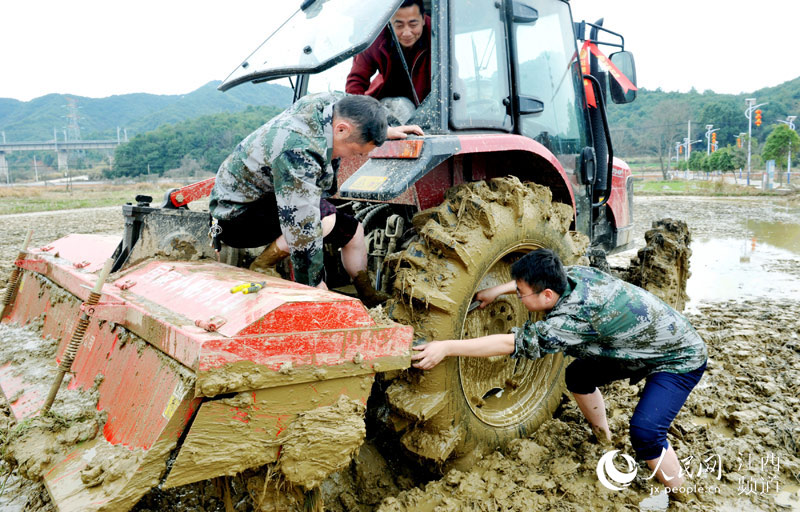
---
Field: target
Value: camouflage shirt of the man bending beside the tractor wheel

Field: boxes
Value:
[511,266,708,382]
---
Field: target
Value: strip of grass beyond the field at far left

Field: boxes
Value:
[0,183,179,215]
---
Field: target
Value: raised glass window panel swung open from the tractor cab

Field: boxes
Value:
[219,0,401,91]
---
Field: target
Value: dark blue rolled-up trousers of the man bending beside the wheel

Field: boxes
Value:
[565,359,706,460]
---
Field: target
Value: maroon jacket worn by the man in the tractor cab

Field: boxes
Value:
[345,16,431,102]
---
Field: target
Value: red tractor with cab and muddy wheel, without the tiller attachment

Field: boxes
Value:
[220,0,636,463]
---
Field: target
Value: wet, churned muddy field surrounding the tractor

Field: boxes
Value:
[0,197,800,512]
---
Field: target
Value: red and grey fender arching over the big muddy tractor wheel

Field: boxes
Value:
[339,133,575,214]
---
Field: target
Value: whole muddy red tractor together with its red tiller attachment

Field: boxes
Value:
[0,0,636,510]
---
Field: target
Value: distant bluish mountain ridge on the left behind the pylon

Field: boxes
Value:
[0,81,292,142]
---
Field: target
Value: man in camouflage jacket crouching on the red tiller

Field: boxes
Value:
[209,93,422,307]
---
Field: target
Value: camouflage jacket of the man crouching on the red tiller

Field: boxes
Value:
[209,93,345,286]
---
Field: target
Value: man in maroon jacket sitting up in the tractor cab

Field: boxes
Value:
[345,0,431,107]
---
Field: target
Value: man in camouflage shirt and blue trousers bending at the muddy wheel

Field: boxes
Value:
[411,249,708,501]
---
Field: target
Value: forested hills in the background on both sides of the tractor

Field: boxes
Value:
[7,73,800,177]
